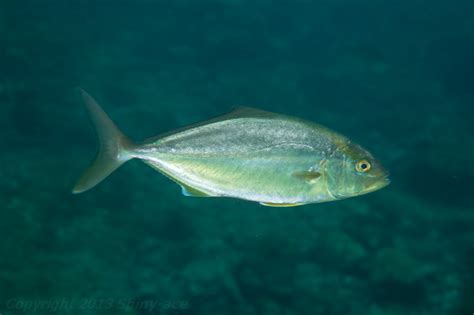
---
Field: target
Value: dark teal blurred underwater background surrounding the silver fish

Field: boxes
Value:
[0,0,474,315]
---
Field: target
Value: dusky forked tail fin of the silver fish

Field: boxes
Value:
[72,89,133,194]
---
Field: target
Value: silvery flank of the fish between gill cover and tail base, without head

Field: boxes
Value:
[138,113,344,204]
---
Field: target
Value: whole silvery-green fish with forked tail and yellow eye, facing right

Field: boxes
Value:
[72,89,390,207]
